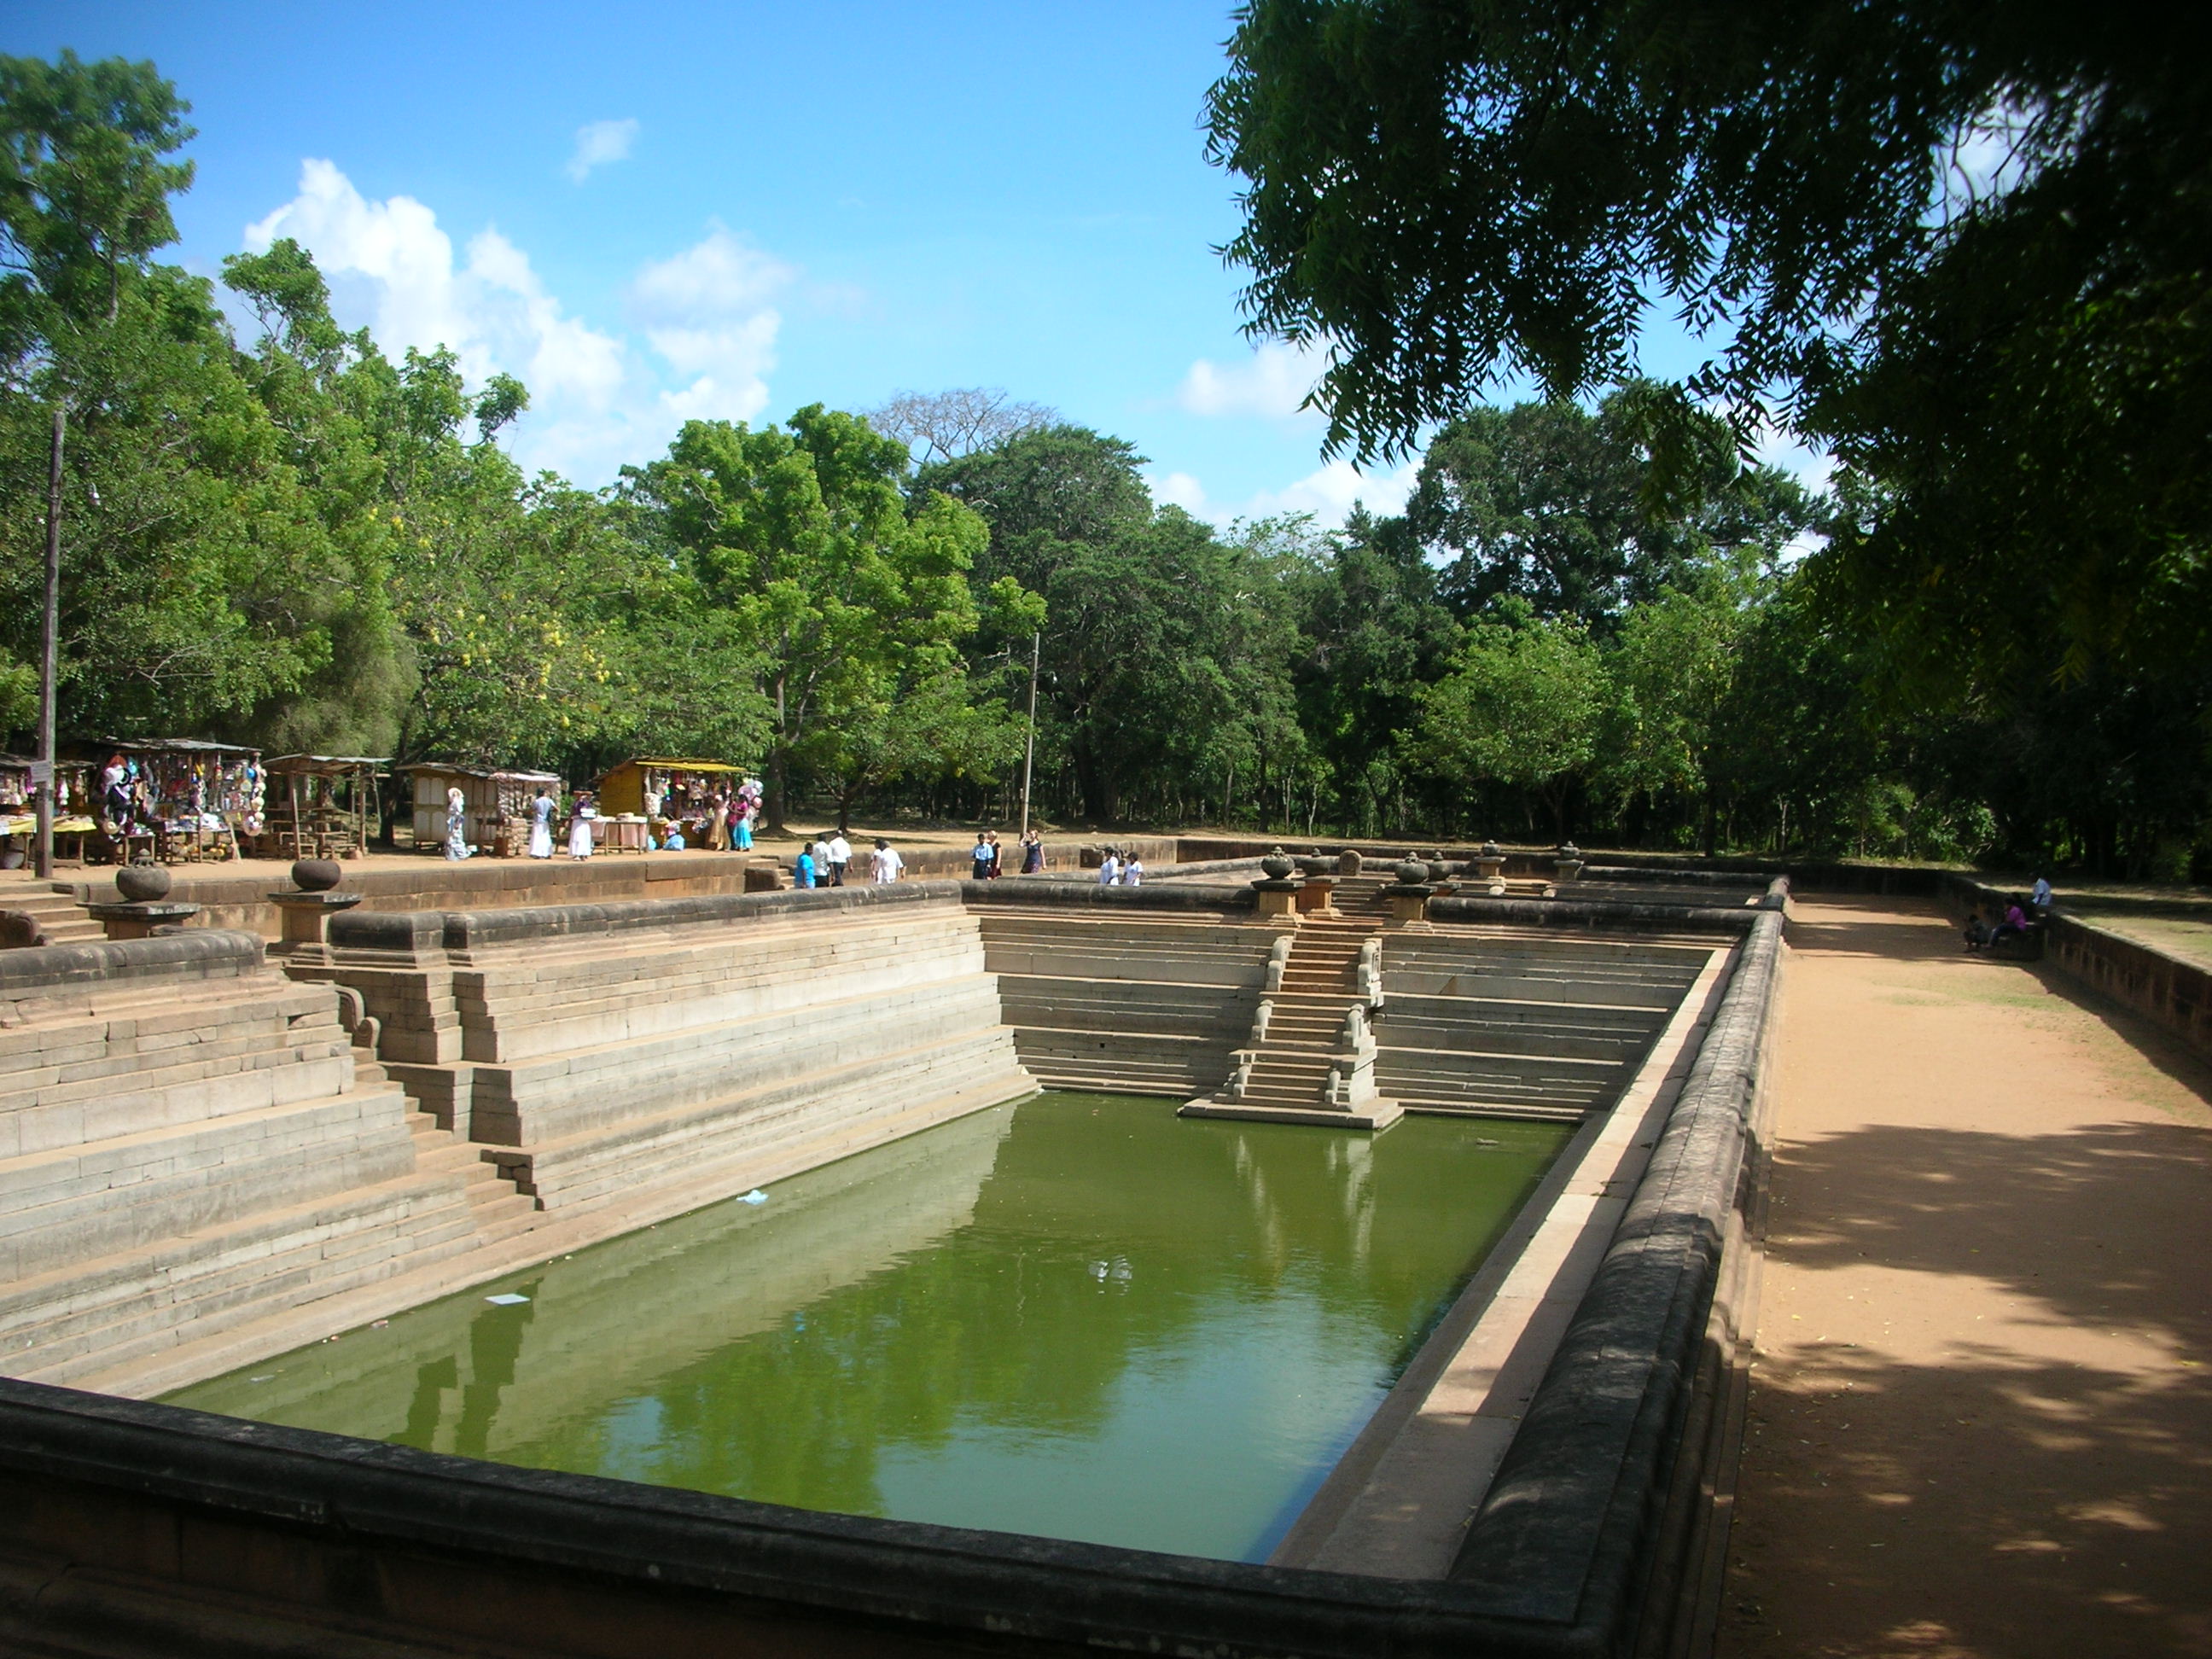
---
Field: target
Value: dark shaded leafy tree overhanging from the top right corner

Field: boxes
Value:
[1210,0,2212,734]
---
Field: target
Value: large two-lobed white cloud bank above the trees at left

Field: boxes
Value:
[243,161,799,485]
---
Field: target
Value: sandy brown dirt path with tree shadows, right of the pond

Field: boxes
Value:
[1719,900,2212,1659]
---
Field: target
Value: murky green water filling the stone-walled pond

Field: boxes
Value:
[168,1092,1569,1559]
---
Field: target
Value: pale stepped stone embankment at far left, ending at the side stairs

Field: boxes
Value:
[0,929,544,1382]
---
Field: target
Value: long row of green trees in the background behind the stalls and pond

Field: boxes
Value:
[0,57,2212,876]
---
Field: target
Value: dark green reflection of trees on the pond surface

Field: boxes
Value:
[568,1099,1559,1513]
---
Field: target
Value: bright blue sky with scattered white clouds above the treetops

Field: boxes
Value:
[0,0,1796,522]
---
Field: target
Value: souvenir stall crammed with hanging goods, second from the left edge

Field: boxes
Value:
[90,736,268,864]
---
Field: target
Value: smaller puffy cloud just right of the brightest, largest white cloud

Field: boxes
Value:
[631,225,799,420]
